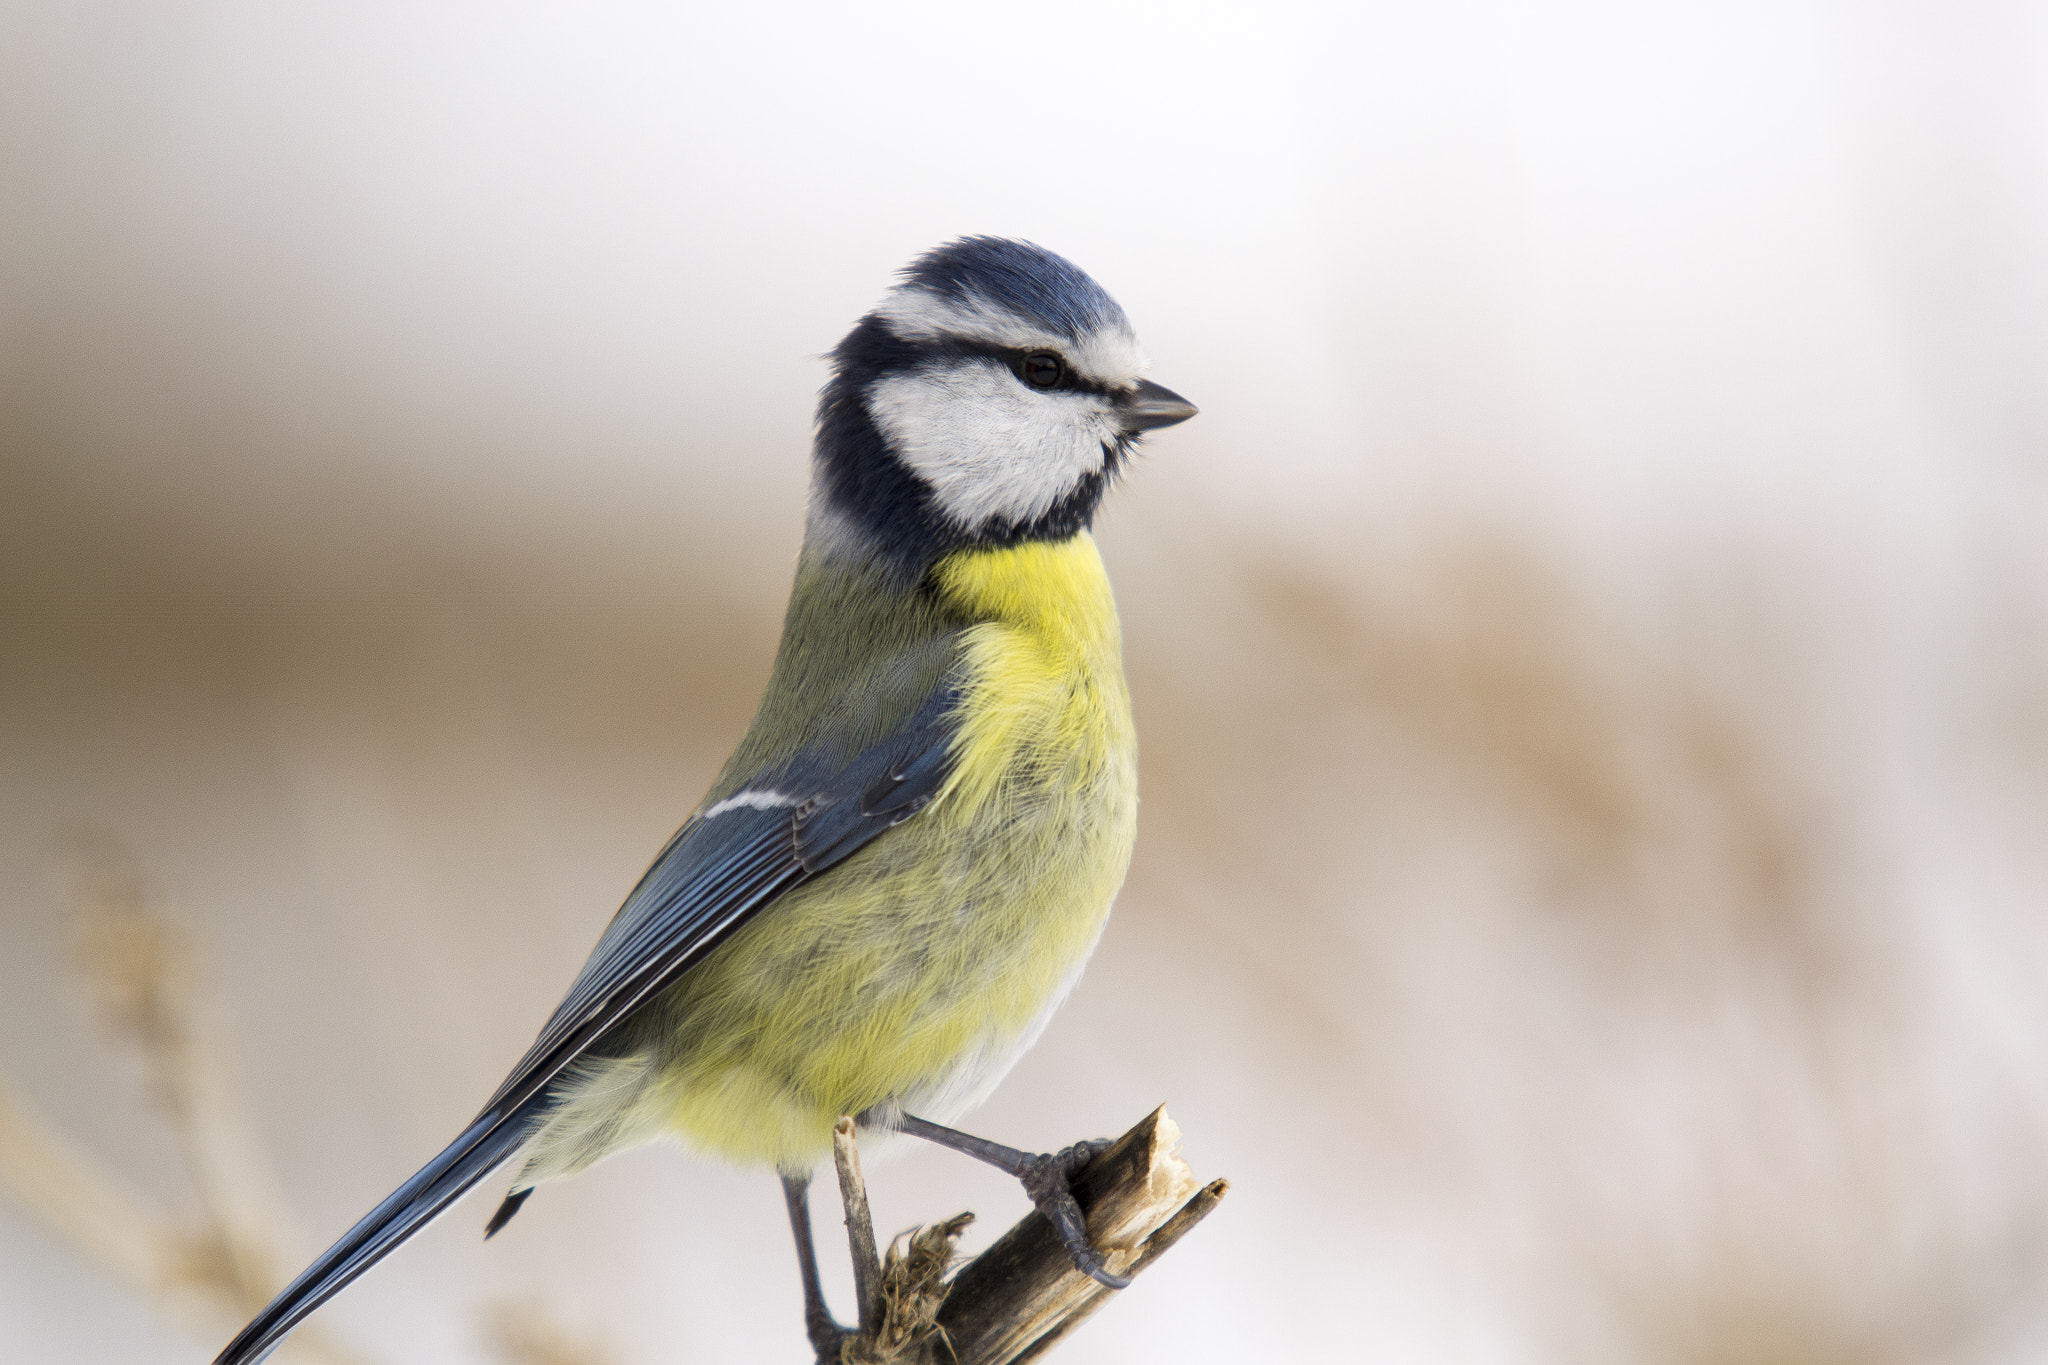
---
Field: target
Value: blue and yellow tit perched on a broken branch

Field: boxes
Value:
[215,235,1196,1365]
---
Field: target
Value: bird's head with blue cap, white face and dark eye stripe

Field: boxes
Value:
[811,237,1194,577]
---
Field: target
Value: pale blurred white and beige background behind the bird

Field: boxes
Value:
[0,0,2048,1365]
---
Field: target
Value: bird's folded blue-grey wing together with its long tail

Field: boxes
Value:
[213,686,954,1365]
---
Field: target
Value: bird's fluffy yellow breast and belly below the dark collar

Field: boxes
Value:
[651,534,1137,1169]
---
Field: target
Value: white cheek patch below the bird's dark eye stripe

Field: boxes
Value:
[868,360,1116,530]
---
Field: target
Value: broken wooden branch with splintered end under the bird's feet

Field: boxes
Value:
[834,1107,1229,1365]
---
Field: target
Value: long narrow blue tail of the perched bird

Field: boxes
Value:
[213,1093,547,1365]
